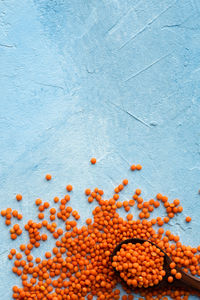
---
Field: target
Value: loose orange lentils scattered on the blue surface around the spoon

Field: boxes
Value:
[1,159,200,300]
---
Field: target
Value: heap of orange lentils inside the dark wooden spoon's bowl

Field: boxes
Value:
[112,242,166,288]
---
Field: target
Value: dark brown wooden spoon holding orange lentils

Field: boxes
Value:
[111,239,200,291]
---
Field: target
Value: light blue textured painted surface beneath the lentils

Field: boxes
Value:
[0,0,200,299]
